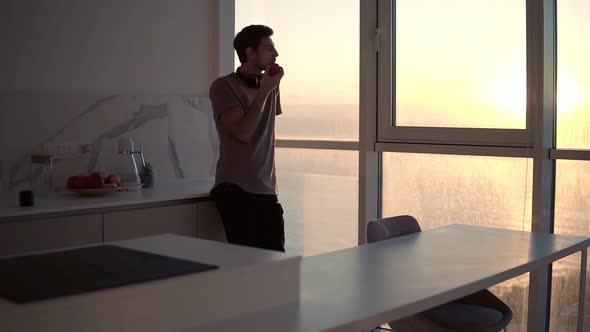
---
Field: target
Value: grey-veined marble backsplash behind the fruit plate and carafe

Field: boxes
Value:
[0,92,218,191]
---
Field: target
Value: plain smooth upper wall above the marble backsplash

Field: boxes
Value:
[0,0,217,94]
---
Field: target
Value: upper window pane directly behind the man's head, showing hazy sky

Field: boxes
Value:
[235,0,360,140]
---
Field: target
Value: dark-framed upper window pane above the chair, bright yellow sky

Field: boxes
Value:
[395,0,526,129]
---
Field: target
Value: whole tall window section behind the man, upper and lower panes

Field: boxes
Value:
[236,0,360,256]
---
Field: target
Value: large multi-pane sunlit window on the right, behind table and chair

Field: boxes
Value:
[376,0,590,331]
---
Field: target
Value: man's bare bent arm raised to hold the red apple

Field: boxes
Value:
[220,68,284,143]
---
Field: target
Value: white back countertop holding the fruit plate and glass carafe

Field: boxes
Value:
[0,178,214,222]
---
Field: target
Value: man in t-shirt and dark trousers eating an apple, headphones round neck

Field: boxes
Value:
[209,25,285,252]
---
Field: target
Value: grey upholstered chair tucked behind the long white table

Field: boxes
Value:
[367,216,513,332]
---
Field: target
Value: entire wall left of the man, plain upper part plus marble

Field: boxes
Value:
[0,0,219,190]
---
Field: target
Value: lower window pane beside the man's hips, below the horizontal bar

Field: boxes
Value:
[276,148,358,256]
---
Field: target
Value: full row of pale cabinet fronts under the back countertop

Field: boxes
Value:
[0,201,226,256]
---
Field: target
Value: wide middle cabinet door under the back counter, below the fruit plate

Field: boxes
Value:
[104,204,197,242]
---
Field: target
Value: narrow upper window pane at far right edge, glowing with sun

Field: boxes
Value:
[557,0,590,149]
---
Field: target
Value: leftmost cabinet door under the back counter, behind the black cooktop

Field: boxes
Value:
[0,214,102,256]
